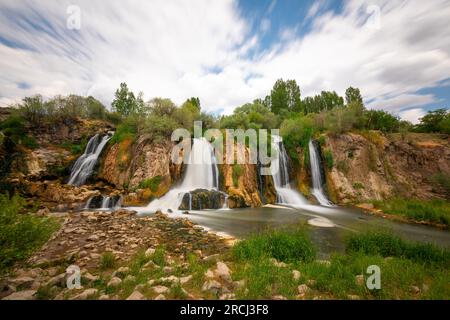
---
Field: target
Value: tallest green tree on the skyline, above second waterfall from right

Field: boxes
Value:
[266,79,302,115]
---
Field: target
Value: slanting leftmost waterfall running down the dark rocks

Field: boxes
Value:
[68,134,111,187]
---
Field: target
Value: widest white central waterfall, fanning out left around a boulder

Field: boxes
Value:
[146,138,219,212]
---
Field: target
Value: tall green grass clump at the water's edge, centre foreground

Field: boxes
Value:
[232,228,316,262]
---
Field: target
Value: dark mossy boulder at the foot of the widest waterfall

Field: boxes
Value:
[180,189,226,210]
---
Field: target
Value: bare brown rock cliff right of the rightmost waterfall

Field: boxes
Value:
[326,132,450,203]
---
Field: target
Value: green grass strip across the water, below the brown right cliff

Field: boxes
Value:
[373,198,450,227]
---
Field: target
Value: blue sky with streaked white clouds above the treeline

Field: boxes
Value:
[0,0,450,123]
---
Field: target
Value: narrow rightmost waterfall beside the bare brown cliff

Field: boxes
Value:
[309,140,334,207]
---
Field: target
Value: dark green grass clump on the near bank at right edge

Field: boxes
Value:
[346,231,450,268]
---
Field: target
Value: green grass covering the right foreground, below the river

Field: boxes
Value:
[231,229,450,299]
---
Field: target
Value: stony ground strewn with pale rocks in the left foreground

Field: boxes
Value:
[0,210,240,300]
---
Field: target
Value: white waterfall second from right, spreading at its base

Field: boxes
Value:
[270,136,307,205]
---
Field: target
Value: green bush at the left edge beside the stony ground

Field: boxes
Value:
[0,194,59,272]
